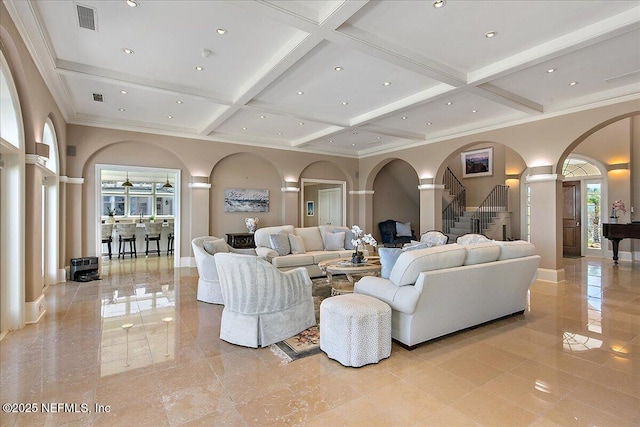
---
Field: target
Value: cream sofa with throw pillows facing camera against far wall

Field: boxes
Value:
[253,225,354,277]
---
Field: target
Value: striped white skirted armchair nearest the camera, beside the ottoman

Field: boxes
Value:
[216,253,316,348]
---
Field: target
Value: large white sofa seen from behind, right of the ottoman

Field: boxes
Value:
[354,241,540,348]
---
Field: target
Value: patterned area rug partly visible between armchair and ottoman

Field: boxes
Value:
[271,277,331,363]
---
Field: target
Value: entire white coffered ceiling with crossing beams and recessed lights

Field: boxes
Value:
[4,0,640,157]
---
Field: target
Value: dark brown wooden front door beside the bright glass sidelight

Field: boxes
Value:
[562,181,582,256]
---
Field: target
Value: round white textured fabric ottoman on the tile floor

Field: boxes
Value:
[320,294,391,367]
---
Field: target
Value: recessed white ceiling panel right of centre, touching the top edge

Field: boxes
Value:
[348,0,638,73]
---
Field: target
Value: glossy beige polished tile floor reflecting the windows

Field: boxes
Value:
[0,257,640,427]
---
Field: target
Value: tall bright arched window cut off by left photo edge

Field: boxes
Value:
[0,52,25,337]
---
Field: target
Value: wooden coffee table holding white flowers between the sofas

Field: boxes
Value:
[318,256,382,296]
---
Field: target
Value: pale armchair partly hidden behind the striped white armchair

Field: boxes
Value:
[191,236,256,304]
